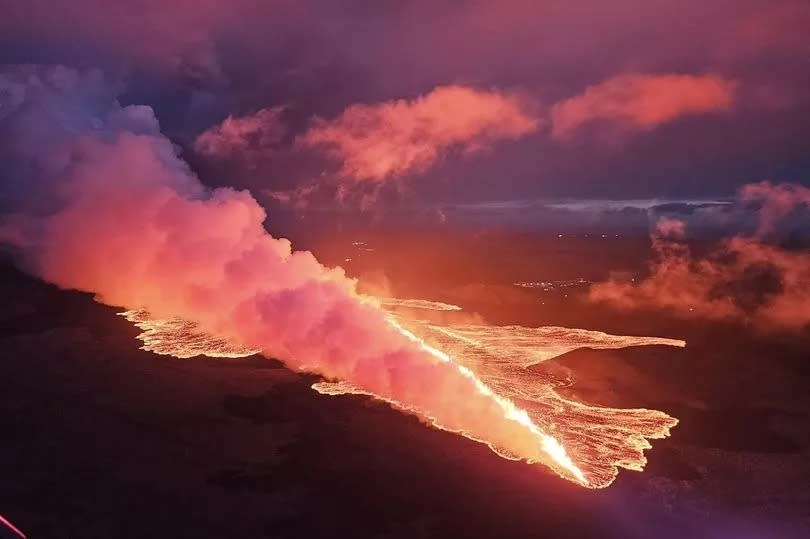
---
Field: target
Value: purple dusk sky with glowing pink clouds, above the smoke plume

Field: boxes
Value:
[0,0,810,212]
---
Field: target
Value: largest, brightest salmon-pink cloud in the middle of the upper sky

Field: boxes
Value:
[298,86,540,182]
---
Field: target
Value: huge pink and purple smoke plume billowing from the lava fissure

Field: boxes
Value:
[0,67,580,480]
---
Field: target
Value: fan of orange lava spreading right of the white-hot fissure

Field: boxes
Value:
[378,319,686,488]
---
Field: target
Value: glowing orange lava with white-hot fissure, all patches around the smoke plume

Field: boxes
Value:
[122,299,685,488]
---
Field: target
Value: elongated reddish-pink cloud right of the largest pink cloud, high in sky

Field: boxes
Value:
[551,74,735,137]
